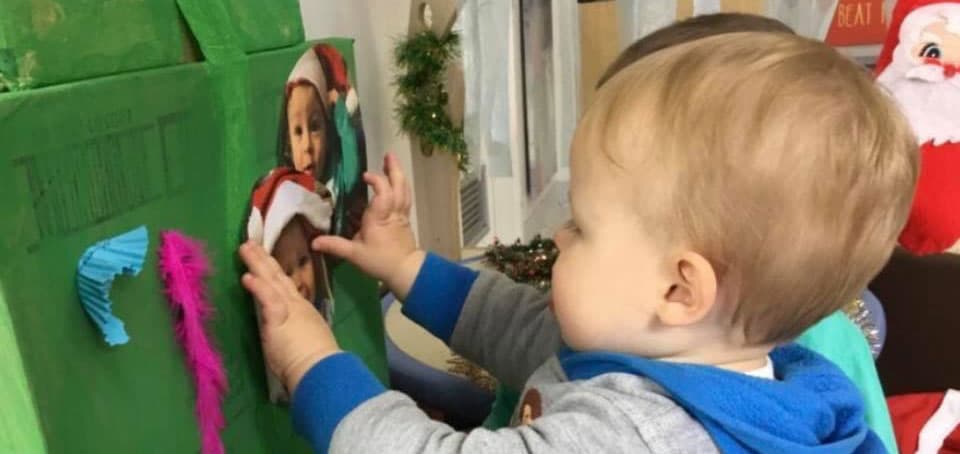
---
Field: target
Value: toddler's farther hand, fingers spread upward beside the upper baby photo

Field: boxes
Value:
[313,154,426,300]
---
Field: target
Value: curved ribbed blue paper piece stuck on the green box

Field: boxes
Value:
[77,226,149,347]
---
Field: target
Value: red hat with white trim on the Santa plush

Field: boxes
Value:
[876,0,960,74]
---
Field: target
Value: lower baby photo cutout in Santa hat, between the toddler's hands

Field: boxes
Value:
[247,167,333,402]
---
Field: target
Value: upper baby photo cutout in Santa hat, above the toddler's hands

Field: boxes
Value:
[277,44,367,238]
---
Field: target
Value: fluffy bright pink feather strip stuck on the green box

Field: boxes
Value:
[159,230,227,454]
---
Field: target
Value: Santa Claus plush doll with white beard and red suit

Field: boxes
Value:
[877,0,960,254]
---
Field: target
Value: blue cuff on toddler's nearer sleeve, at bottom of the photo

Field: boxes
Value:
[291,353,384,452]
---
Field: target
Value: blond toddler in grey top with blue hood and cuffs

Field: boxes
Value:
[240,32,918,453]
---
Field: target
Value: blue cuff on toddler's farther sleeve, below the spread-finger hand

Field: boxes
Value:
[403,254,479,344]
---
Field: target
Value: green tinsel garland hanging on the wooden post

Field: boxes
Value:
[394,31,470,171]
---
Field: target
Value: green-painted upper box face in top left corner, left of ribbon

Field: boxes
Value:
[0,0,187,91]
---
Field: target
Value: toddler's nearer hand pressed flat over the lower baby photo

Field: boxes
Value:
[240,243,340,394]
